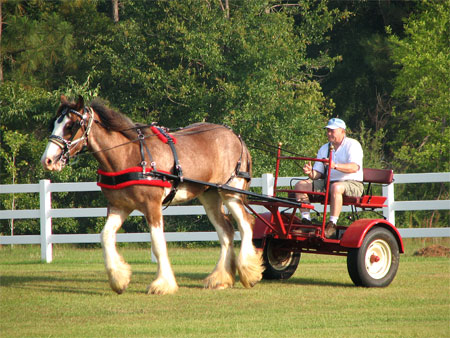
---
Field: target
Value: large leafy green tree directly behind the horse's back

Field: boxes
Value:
[91,1,342,177]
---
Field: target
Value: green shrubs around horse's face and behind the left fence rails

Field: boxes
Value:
[0,77,101,234]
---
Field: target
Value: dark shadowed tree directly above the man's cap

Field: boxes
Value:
[319,0,417,132]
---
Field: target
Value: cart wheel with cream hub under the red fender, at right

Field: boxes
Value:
[347,227,399,287]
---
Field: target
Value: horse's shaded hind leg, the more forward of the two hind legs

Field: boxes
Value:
[199,190,236,289]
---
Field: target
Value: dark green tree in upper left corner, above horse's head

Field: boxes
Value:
[0,0,111,91]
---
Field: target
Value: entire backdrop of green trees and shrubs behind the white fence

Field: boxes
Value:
[0,0,450,233]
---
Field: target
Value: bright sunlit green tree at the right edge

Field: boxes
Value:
[390,1,450,172]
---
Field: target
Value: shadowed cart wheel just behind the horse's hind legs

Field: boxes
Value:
[263,239,300,279]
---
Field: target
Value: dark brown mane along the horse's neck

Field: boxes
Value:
[90,99,136,139]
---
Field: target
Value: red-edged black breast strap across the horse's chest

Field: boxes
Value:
[97,167,172,190]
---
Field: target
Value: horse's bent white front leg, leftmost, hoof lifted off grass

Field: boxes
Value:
[101,208,131,294]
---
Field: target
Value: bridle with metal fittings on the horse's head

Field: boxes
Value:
[48,106,94,166]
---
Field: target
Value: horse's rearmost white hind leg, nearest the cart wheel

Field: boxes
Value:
[221,193,264,288]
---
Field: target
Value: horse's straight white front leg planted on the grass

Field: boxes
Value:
[146,206,178,295]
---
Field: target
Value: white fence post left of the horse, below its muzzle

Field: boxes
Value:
[39,180,53,263]
